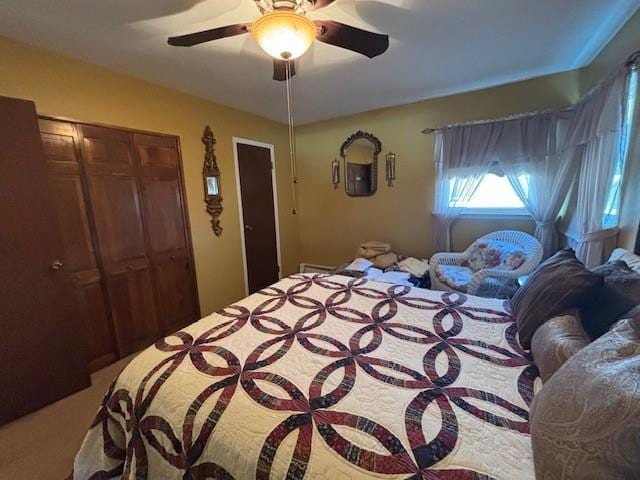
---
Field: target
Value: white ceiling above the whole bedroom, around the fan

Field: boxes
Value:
[0,0,640,123]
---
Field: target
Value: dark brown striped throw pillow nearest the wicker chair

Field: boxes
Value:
[511,248,603,348]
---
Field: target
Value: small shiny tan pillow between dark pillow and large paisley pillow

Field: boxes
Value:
[531,311,591,383]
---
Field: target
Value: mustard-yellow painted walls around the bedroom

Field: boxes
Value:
[0,4,640,314]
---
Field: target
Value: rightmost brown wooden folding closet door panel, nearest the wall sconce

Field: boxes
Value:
[134,134,200,334]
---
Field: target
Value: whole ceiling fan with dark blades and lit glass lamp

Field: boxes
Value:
[169,0,389,81]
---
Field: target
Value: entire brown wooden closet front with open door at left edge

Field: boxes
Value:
[0,97,200,424]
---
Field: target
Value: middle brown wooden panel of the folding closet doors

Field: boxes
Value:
[78,125,160,356]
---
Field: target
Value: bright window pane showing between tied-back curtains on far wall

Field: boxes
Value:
[450,173,528,215]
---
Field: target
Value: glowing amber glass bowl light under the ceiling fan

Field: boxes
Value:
[251,11,318,60]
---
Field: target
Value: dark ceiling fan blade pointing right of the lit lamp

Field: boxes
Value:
[314,20,389,58]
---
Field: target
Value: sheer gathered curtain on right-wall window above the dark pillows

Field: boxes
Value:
[562,68,629,267]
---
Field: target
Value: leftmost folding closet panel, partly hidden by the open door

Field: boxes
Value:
[40,119,118,372]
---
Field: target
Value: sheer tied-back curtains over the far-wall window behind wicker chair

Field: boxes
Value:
[434,113,556,251]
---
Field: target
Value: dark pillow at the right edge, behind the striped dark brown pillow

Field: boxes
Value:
[582,260,640,339]
